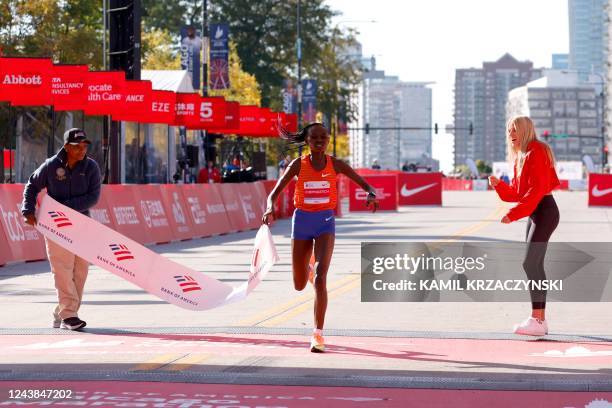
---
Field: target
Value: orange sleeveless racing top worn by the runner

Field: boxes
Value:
[293,154,338,211]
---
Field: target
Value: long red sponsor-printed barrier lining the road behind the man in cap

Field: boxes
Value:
[0,180,306,265]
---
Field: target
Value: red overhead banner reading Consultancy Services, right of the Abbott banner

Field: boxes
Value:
[51,65,88,111]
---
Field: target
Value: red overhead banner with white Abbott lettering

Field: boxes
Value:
[0,58,53,106]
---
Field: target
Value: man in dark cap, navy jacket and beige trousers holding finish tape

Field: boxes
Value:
[21,128,101,330]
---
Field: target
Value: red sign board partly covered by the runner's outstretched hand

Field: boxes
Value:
[349,174,398,211]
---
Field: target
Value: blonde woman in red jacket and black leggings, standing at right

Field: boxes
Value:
[489,116,559,336]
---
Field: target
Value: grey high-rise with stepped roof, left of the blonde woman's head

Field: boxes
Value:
[454,54,542,166]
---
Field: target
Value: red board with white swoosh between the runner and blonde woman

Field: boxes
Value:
[397,172,442,205]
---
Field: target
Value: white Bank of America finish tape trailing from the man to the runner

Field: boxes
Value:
[37,195,278,310]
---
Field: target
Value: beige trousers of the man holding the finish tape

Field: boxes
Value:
[45,238,89,320]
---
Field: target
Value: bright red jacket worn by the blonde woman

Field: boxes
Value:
[495,141,559,221]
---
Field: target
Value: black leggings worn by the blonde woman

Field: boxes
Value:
[523,195,559,309]
